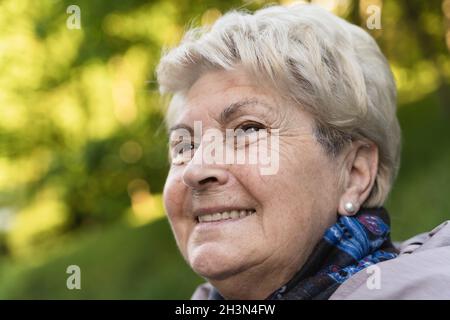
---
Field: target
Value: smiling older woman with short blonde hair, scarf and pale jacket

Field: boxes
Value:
[157,4,450,299]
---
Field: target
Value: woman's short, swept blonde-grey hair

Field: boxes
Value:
[157,4,401,207]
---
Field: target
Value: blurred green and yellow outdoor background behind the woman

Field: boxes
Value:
[0,0,450,299]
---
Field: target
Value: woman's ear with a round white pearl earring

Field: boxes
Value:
[338,141,378,215]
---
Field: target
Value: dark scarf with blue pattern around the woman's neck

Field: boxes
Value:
[209,207,398,300]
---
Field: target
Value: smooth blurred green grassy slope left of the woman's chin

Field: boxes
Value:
[0,220,200,299]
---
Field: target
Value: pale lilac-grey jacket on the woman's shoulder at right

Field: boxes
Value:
[330,221,450,300]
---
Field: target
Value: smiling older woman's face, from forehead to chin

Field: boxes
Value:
[164,71,339,283]
